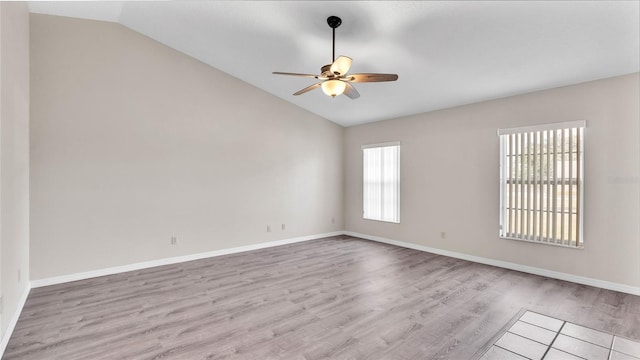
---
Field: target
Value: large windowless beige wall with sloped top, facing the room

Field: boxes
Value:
[31,14,343,280]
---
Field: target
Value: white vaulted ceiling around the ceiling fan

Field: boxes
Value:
[29,1,640,126]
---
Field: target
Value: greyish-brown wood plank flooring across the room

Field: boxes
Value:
[3,236,640,360]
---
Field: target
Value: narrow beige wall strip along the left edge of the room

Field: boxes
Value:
[0,2,29,335]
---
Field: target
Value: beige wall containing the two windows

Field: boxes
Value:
[344,73,640,287]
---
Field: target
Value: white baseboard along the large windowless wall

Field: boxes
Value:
[31,231,344,288]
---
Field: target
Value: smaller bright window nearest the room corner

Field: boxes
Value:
[362,142,400,223]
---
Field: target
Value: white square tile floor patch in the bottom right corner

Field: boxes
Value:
[480,311,640,360]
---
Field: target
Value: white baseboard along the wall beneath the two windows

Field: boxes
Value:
[344,231,640,295]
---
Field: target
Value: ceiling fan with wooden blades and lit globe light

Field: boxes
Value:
[273,16,398,99]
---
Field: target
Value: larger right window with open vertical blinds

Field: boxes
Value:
[498,121,585,248]
